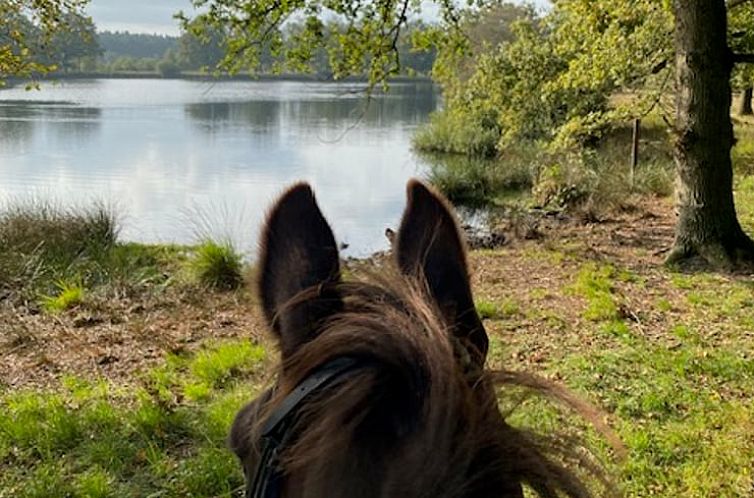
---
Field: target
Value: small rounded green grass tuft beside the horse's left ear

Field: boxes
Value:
[189,240,243,290]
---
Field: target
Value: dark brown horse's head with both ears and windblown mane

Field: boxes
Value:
[230,181,604,498]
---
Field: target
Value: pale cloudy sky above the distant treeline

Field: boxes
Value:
[87,0,548,35]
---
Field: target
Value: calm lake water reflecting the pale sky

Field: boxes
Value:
[0,80,438,255]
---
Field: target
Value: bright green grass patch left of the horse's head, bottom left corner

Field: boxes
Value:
[0,341,265,498]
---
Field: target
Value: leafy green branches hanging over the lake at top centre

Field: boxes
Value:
[179,0,440,85]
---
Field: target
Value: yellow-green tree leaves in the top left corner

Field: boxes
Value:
[0,0,88,84]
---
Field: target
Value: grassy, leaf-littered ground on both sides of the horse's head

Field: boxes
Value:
[0,193,754,498]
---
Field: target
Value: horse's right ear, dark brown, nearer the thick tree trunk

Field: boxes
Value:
[394,180,489,365]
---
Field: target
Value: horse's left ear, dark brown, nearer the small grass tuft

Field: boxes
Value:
[259,183,343,358]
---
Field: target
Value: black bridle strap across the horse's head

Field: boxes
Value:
[246,356,359,498]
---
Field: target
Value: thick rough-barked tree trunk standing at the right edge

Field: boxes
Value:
[668,0,754,269]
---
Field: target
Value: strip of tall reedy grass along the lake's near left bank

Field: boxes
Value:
[0,201,250,313]
